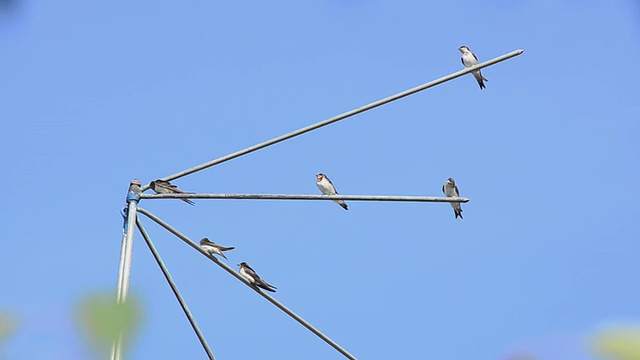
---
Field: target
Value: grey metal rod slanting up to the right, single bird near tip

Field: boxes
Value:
[142,50,524,191]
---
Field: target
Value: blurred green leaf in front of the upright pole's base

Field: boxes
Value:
[77,292,142,358]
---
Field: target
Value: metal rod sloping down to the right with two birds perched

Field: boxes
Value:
[138,208,356,360]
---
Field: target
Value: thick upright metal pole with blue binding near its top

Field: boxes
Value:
[111,179,141,360]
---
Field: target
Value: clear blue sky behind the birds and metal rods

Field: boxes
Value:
[0,0,640,360]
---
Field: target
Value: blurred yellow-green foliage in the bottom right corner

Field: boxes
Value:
[593,326,640,360]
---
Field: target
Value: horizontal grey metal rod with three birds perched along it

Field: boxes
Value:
[140,194,469,203]
